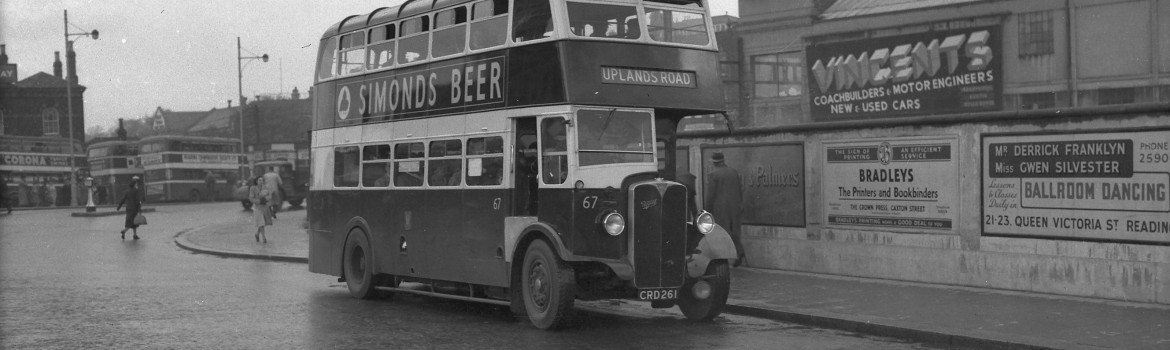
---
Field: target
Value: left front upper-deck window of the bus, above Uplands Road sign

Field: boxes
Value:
[566,2,641,40]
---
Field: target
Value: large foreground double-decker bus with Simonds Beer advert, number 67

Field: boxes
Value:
[308,0,736,329]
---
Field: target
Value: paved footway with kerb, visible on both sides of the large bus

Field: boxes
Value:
[176,210,1170,349]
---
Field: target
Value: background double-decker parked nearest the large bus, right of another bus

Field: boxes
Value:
[138,135,240,201]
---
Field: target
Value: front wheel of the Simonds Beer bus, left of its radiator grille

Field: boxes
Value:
[519,240,576,329]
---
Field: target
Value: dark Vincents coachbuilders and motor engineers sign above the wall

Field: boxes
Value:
[806,27,1003,121]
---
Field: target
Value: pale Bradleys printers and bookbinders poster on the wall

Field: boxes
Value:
[821,136,958,233]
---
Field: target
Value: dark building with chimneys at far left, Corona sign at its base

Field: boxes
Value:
[0,44,87,206]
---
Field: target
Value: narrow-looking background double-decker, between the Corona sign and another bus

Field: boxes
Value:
[87,138,143,204]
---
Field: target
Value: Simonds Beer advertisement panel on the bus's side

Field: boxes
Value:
[335,55,507,124]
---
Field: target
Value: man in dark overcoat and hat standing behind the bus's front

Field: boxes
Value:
[703,151,746,267]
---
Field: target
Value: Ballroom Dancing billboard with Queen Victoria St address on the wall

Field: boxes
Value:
[983,131,1170,242]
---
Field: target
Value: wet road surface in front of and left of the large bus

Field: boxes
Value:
[0,203,945,349]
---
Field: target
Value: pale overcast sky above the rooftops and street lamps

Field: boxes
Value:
[0,0,738,129]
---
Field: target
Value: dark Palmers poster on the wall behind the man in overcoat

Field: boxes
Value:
[698,143,805,227]
